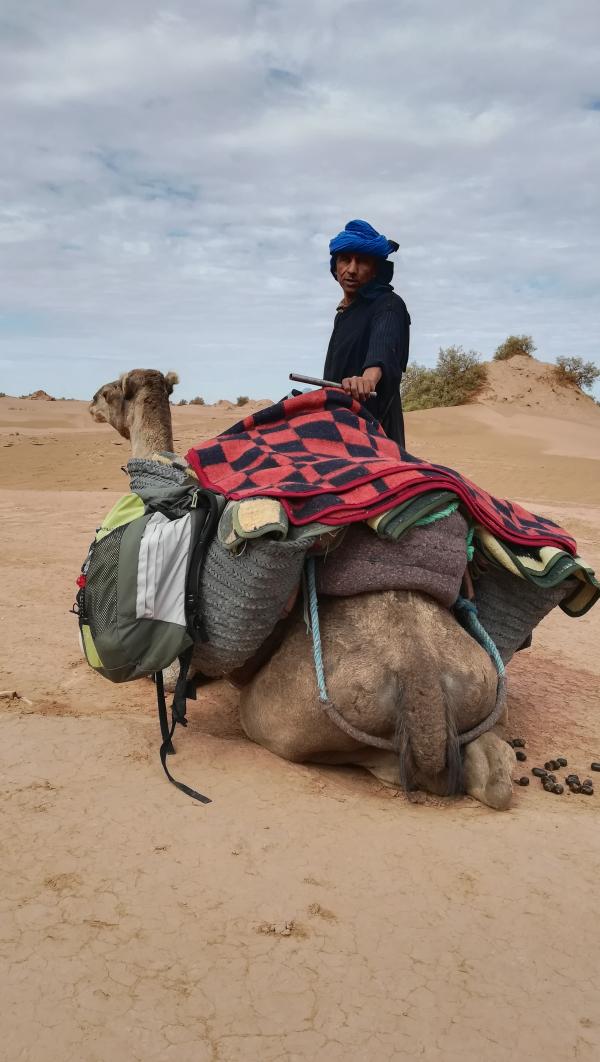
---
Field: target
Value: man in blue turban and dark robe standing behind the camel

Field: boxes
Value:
[323,221,410,446]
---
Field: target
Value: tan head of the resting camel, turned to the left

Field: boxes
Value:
[89,369,179,439]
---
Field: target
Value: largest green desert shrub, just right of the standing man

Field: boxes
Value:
[401,346,487,413]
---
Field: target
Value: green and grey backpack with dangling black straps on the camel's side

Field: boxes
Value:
[72,485,220,804]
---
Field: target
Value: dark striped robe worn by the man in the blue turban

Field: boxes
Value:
[323,281,410,447]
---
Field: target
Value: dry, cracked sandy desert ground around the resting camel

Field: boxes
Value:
[0,399,600,1062]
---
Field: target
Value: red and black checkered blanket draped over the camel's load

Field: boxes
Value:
[186,388,577,554]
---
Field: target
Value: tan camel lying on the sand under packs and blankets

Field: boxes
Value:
[89,370,516,810]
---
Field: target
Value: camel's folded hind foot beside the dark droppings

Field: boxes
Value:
[463,730,516,811]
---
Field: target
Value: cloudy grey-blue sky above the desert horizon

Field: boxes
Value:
[0,0,600,401]
